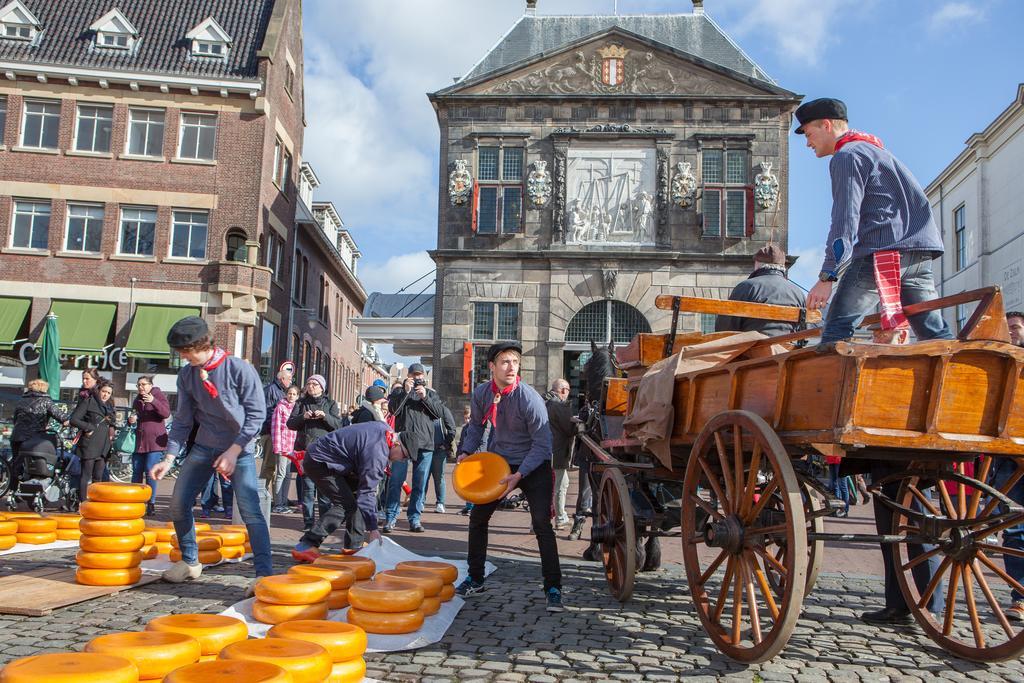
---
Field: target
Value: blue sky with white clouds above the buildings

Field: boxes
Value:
[303,0,1024,358]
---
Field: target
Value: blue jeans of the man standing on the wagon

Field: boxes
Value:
[821,251,953,344]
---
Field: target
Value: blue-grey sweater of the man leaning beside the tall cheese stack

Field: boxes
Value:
[164,355,266,455]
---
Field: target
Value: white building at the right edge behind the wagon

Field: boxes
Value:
[926,83,1024,330]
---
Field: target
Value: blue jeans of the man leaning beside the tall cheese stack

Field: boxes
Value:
[171,443,273,577]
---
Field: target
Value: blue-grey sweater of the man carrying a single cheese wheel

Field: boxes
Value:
[462,382,551,477]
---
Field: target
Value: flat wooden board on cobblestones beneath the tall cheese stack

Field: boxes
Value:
[0,567,160,616]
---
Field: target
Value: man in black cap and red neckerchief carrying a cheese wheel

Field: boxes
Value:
[456,342,563,611]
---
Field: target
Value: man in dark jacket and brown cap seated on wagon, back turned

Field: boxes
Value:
[715,245,805,337]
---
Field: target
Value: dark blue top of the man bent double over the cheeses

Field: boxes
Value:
[306,421,390,531]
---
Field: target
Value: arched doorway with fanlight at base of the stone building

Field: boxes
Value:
[561,299,650,403]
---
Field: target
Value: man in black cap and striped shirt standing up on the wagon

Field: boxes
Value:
[796,98,952,352]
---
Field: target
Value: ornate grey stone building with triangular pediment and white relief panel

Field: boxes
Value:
[430,1,799,402]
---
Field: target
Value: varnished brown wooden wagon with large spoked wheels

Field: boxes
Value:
[581,288,1024,661]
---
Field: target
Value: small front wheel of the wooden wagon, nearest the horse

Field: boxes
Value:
[591,468,637,602]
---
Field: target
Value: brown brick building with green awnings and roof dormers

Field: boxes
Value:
[0,0,304,411]
